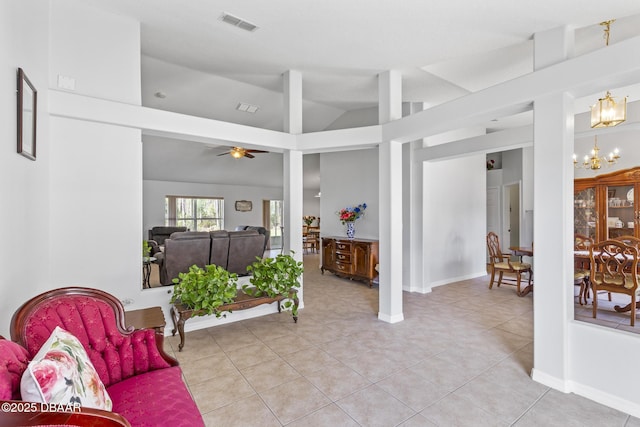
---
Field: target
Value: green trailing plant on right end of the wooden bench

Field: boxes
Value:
[242,251,304,316]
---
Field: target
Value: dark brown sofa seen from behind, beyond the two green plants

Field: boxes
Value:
[155,230,265,286]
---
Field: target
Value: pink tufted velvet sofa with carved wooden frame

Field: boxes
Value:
[0,287,204,427]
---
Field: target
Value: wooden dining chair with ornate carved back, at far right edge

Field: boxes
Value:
[589,240,638,326]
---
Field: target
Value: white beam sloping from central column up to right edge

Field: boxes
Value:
[382,37,640,142]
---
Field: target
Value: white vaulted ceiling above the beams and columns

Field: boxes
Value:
[83,0,640,187]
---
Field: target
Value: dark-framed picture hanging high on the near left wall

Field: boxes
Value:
[17,68,38,160]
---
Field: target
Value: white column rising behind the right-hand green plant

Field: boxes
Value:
[282,70,303,278]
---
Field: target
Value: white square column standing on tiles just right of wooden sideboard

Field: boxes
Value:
[378,70,404,323]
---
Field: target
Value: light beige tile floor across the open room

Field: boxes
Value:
[166,255,640,427]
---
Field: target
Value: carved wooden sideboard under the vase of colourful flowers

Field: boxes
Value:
[320,237,378,287]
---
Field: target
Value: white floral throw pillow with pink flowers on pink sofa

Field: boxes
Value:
[20,326,112,411]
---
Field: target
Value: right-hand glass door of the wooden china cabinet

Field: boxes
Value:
[606,185,635,239]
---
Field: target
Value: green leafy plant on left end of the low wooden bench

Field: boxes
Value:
[171,264,238,317]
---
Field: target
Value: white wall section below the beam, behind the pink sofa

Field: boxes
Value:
[49,117,142,294]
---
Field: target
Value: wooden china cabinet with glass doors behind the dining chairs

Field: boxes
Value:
[573,167,640,242]
